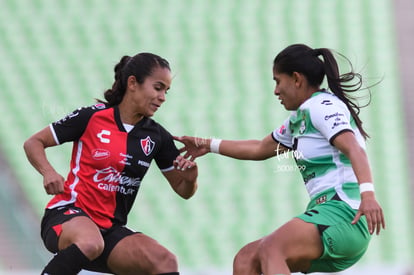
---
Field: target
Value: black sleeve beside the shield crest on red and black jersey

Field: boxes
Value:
[154,127,180,172]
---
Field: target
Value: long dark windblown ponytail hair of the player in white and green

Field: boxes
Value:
[273,44,371,139]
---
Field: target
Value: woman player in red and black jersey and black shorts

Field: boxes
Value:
[24,53,198,275]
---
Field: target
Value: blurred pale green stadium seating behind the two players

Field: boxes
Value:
[0,0,414,275]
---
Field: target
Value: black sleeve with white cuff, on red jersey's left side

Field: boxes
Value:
[50,104,105,144]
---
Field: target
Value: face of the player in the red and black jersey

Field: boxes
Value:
[134,67,171,117]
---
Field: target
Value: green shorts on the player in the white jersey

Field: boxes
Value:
[297,200,371,273]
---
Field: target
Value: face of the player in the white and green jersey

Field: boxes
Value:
[273,72,303,111]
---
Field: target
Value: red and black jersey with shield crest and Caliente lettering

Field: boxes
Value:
[47,104,179,228]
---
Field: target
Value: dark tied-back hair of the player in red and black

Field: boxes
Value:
[98,53,171,107]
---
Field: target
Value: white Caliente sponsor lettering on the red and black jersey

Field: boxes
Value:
[93,167,141,195]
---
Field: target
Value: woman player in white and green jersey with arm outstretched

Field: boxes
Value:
[175,44,385,275]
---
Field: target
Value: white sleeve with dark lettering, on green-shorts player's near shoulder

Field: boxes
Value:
[310,99,353,143]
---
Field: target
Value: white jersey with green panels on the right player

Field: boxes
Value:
[272,90,365,209]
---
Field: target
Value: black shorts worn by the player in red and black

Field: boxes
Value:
[40,205,139,273]
